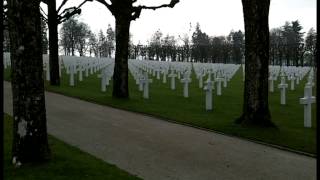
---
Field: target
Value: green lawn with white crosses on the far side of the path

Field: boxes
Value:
[5,66,316,154]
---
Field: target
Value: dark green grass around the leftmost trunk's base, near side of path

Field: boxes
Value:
[4,114,140,180]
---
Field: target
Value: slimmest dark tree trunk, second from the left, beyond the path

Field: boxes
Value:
[48,0,60,86]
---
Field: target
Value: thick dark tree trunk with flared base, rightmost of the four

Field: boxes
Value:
[236,0,274,126]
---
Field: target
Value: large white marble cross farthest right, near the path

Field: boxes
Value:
[300,85,316,127]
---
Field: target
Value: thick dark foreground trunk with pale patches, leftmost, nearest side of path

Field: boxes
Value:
[8,0,50,166]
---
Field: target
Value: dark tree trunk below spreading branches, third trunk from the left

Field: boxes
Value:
[112,15,131,98]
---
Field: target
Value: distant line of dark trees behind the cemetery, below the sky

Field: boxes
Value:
[3,14,317,66]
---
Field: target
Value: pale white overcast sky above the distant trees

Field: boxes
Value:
[45,0,316,43]
